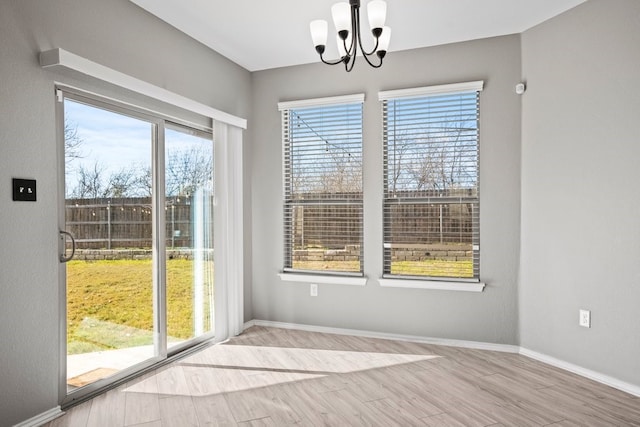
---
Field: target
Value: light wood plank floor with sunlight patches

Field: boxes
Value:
[47,327,640,427]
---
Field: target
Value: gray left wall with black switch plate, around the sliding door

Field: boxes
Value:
[0,0,251,426]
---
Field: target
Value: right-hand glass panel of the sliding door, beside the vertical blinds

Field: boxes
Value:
[165,125,214,348]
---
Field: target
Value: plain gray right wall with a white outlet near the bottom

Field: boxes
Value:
[520,0,640,385]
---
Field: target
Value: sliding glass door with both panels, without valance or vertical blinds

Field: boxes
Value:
[58,91,214,400]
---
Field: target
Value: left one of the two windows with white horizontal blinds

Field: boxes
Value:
[278,95,364,276]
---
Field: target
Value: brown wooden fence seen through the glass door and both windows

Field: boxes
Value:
[66,191,477,249]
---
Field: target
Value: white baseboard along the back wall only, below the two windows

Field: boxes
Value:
[244,319,520,353]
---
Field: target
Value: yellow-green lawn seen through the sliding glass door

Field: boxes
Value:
[67,259,213,354]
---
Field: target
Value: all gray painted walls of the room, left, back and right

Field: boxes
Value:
[5,0,640,426]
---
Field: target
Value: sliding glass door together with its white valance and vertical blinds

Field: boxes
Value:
[47,49,246,405]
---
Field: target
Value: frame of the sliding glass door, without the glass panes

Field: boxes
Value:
[55,84,215,408]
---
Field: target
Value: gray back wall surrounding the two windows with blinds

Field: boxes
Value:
[251,35,521,344]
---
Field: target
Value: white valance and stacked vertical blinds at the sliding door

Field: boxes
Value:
[40,48,247,403]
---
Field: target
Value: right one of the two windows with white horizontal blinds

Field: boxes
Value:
[380,82,482,281]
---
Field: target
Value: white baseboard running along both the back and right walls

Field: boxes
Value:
[244,319,640,397]
